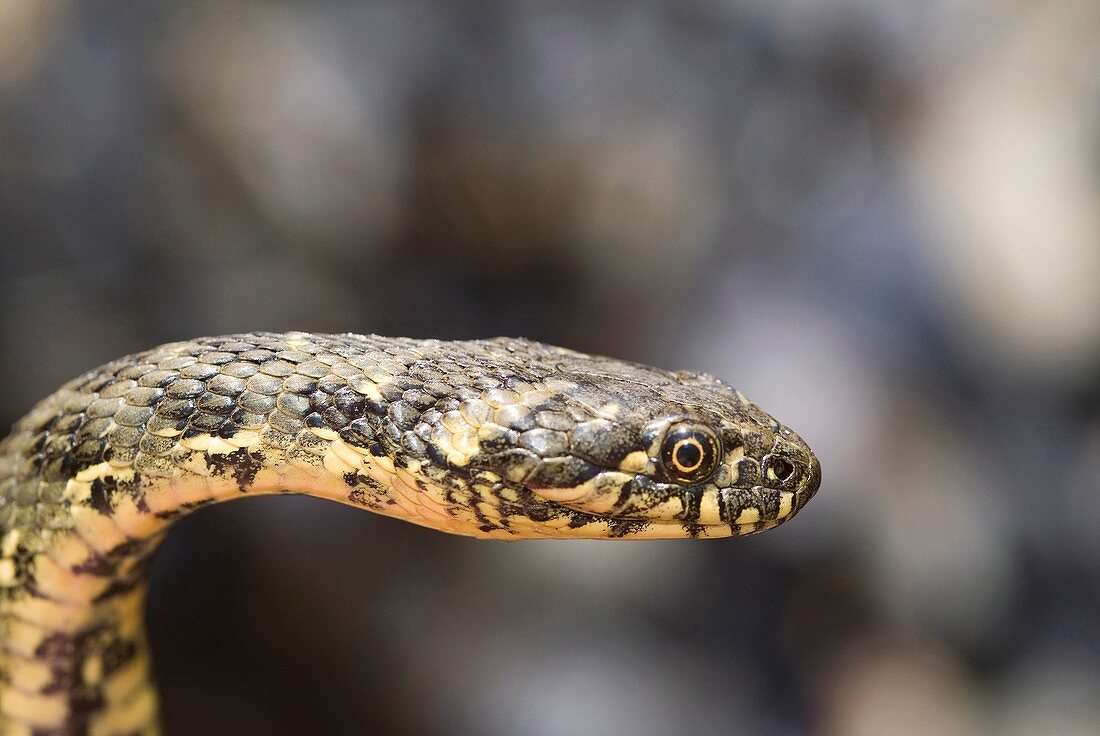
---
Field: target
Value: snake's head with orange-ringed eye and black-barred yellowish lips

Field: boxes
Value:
[451,343,821,537]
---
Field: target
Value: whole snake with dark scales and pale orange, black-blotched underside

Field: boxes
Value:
[0,332,821,736]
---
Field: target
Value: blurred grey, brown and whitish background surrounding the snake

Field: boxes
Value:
[0,0,1100,736]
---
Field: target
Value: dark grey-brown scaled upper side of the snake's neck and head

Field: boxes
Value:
[0,333,827,547]
